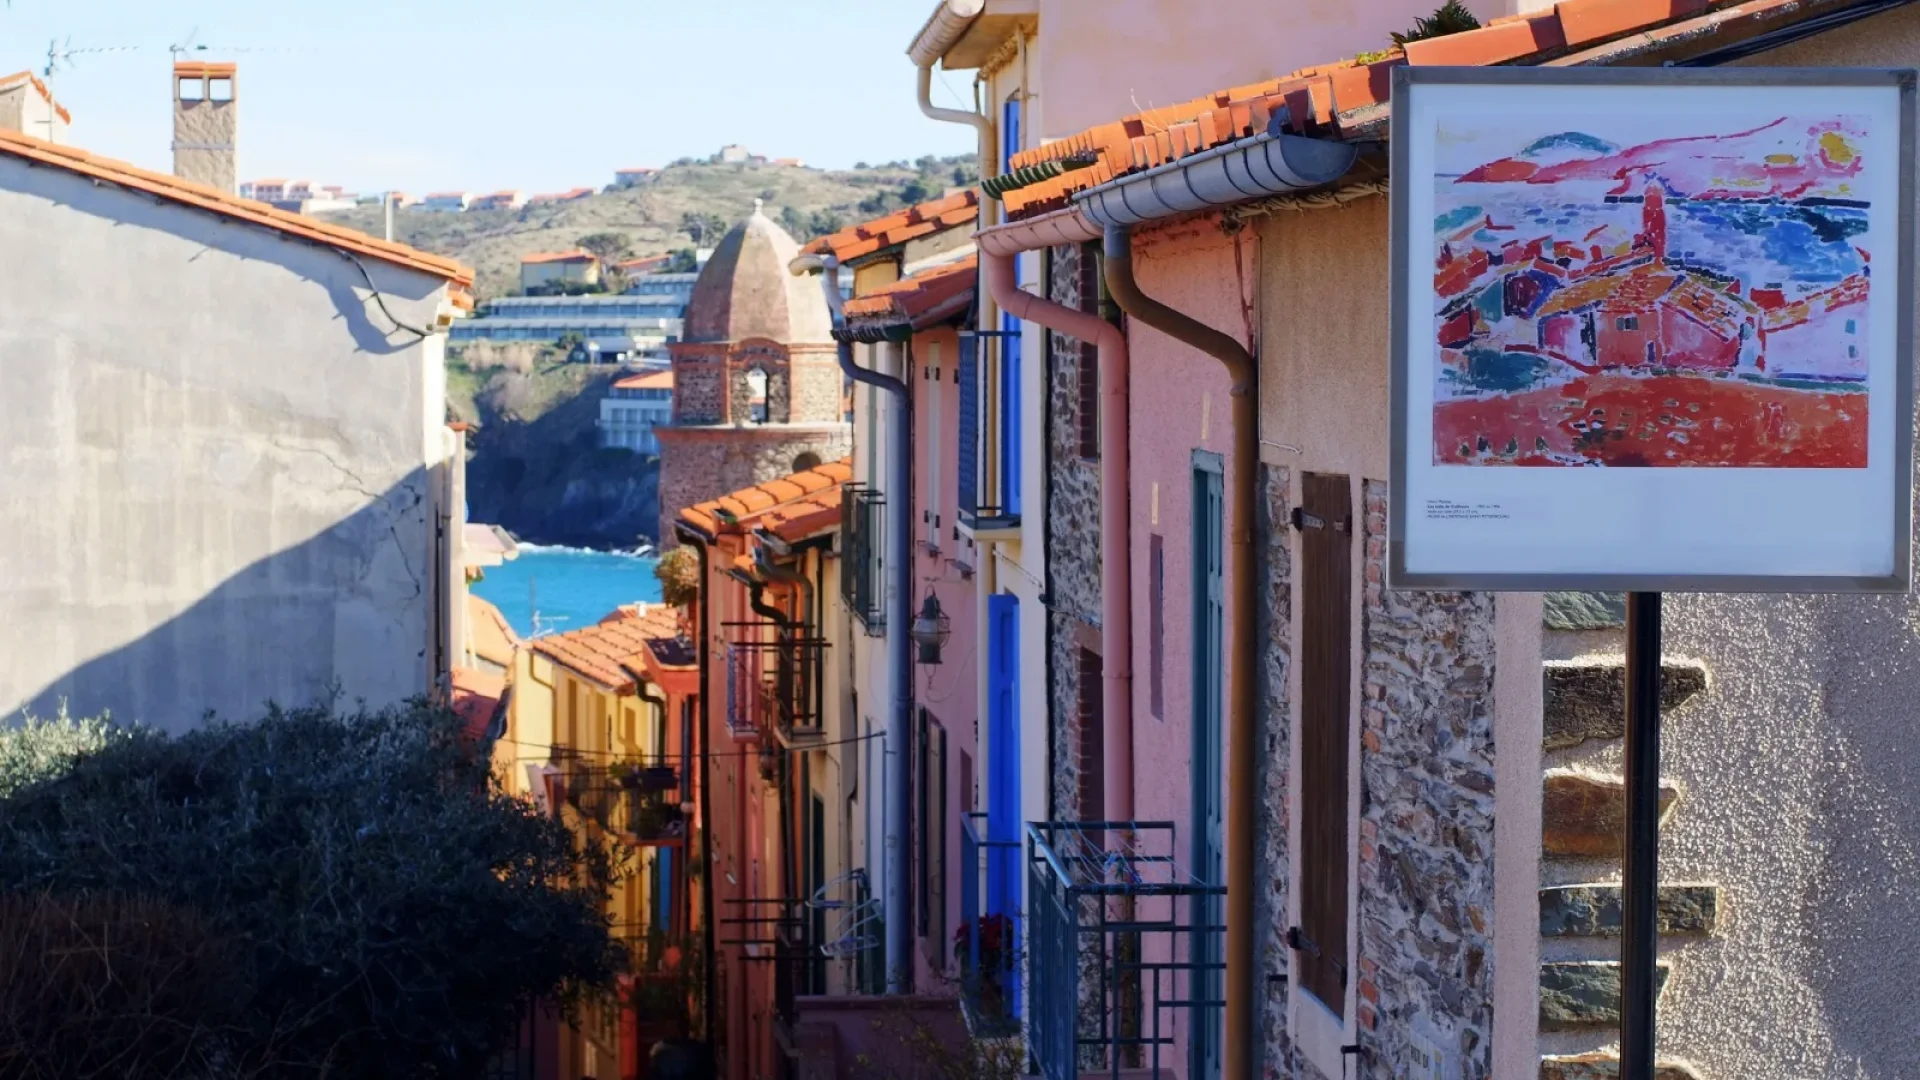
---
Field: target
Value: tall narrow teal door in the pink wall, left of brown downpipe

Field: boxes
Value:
[1188,452,1221,1080]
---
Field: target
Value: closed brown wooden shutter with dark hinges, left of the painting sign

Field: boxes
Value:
[1292,473,1354,1017]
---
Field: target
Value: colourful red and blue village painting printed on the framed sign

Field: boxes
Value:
[1432,115,1874,469]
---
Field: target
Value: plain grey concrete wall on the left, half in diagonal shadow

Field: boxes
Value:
[0,160,445,728]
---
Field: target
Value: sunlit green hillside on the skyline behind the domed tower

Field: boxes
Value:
[324,154,979,298]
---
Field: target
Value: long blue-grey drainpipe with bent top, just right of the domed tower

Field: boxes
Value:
[787,247,914,994]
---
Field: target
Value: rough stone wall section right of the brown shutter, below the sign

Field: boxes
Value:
[1356,480,1494,1080]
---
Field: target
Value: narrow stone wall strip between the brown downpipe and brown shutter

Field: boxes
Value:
[1254,465,1294,1078]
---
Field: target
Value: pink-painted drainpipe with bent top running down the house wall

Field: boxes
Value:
[979,227,1133,821]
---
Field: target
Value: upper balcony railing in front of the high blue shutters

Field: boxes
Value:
[956,323,1021,532]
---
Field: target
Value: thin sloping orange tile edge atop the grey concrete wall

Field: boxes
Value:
[0,131,474,292]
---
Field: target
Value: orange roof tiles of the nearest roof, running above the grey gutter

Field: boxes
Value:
[1002,0,1849,219]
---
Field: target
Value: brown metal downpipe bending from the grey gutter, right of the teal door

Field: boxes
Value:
[1106,225,1260,1080]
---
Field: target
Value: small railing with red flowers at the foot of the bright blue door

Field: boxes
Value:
[954,813,1020,1038]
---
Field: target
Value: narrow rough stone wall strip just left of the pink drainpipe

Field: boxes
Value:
[1046,246,1100,819]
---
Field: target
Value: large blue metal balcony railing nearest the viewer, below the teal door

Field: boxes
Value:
[1027,821,1227,1080]
